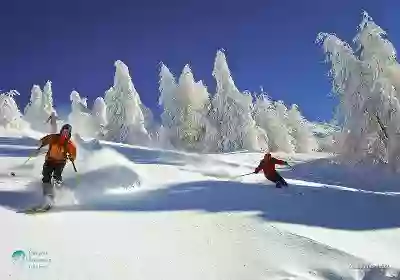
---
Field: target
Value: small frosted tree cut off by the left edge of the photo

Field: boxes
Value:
[0,90,26,129]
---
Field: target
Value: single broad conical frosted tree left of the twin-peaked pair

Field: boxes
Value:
[104,60,150,145]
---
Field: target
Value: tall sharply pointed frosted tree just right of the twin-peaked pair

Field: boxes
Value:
[209,51,260,152]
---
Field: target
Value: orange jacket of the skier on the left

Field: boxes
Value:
[40,134,76,162]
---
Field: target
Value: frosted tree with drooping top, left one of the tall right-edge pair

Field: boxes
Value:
[318,33,368,161]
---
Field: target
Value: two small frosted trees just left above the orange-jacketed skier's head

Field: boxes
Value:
[24,81,56,133]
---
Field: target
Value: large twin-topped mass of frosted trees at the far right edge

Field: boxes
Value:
[317,12,400,170]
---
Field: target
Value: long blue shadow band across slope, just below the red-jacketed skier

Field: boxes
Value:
[50,178,400,230]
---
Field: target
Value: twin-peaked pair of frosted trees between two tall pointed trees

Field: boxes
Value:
[159,64,209,151]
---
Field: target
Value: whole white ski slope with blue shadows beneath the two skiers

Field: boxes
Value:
[0,130,400,280]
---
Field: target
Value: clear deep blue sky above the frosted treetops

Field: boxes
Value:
[0,0,400,120]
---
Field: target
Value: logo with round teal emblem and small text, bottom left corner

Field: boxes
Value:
[11,250,51,269]
